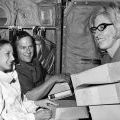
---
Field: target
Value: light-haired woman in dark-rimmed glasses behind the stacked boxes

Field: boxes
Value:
[90,3,120,63]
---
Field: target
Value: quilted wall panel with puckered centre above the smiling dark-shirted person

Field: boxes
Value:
[16,0,40,26]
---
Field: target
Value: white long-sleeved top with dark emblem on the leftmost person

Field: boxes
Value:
[0,71,37,120]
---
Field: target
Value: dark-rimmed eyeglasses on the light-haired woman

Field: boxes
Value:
[90,23,113,33]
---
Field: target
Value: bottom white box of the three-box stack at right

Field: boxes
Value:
[89,105,120,120]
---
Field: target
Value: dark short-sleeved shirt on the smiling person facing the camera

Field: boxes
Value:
[16,59,46,94]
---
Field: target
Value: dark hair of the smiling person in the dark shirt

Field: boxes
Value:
[11,31,35,63]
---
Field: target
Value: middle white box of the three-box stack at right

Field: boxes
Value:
[75,83,120,106]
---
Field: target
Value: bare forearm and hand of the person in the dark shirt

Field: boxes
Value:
[26,75,68,100]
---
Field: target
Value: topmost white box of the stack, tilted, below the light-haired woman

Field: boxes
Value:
[71,62,120,88]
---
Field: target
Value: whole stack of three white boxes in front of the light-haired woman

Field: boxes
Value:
[71,62,120,120]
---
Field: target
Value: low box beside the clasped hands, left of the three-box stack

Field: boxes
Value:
[54,100,89,120]
